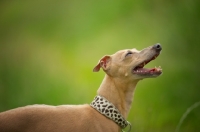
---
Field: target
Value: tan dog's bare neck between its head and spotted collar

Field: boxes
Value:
[97,75,138,119]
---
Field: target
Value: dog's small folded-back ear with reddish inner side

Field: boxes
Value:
[93,55,111,72]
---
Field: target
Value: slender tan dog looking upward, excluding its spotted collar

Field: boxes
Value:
[0,44,162,132]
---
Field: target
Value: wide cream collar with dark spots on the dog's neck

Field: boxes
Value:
[90,95,131,131]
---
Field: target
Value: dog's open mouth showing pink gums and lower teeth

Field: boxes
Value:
[133,54,162,76]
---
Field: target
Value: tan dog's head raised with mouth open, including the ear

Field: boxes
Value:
[93,44,162,80]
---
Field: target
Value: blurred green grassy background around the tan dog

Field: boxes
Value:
[0,0,200,132]
